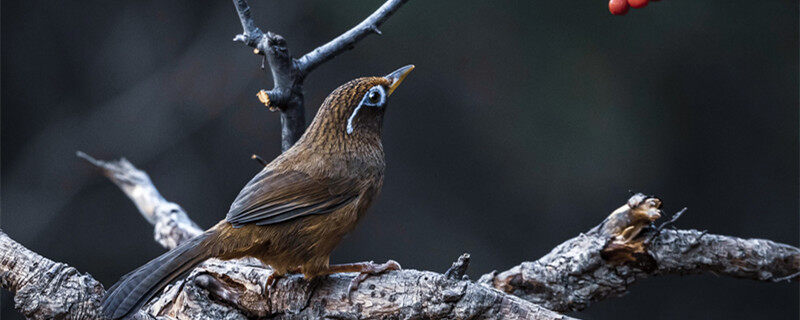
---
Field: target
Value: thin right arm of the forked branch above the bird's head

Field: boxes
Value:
[297,0,408,75]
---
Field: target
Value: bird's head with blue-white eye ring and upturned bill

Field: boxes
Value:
[306,65,414,144]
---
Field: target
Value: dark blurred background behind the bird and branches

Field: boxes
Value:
[2,0,800,319]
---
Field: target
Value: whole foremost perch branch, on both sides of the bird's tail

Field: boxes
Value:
[0,231,571,320]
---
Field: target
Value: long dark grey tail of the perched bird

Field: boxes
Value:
[102,232,212,319]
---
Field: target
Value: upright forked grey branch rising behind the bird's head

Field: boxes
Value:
[233,0,408,151]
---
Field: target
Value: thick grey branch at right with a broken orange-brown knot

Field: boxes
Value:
[479,194,800,312]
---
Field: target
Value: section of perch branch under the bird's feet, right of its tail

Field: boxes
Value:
[147,259,571,319]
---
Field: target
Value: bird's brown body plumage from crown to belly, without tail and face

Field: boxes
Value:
[210,77,389,277]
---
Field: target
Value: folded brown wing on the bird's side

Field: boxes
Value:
[225,170,358,228]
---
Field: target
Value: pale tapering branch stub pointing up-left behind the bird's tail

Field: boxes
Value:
[77,151,203,249]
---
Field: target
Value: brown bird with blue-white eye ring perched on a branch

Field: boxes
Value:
[103,65,414,319]
